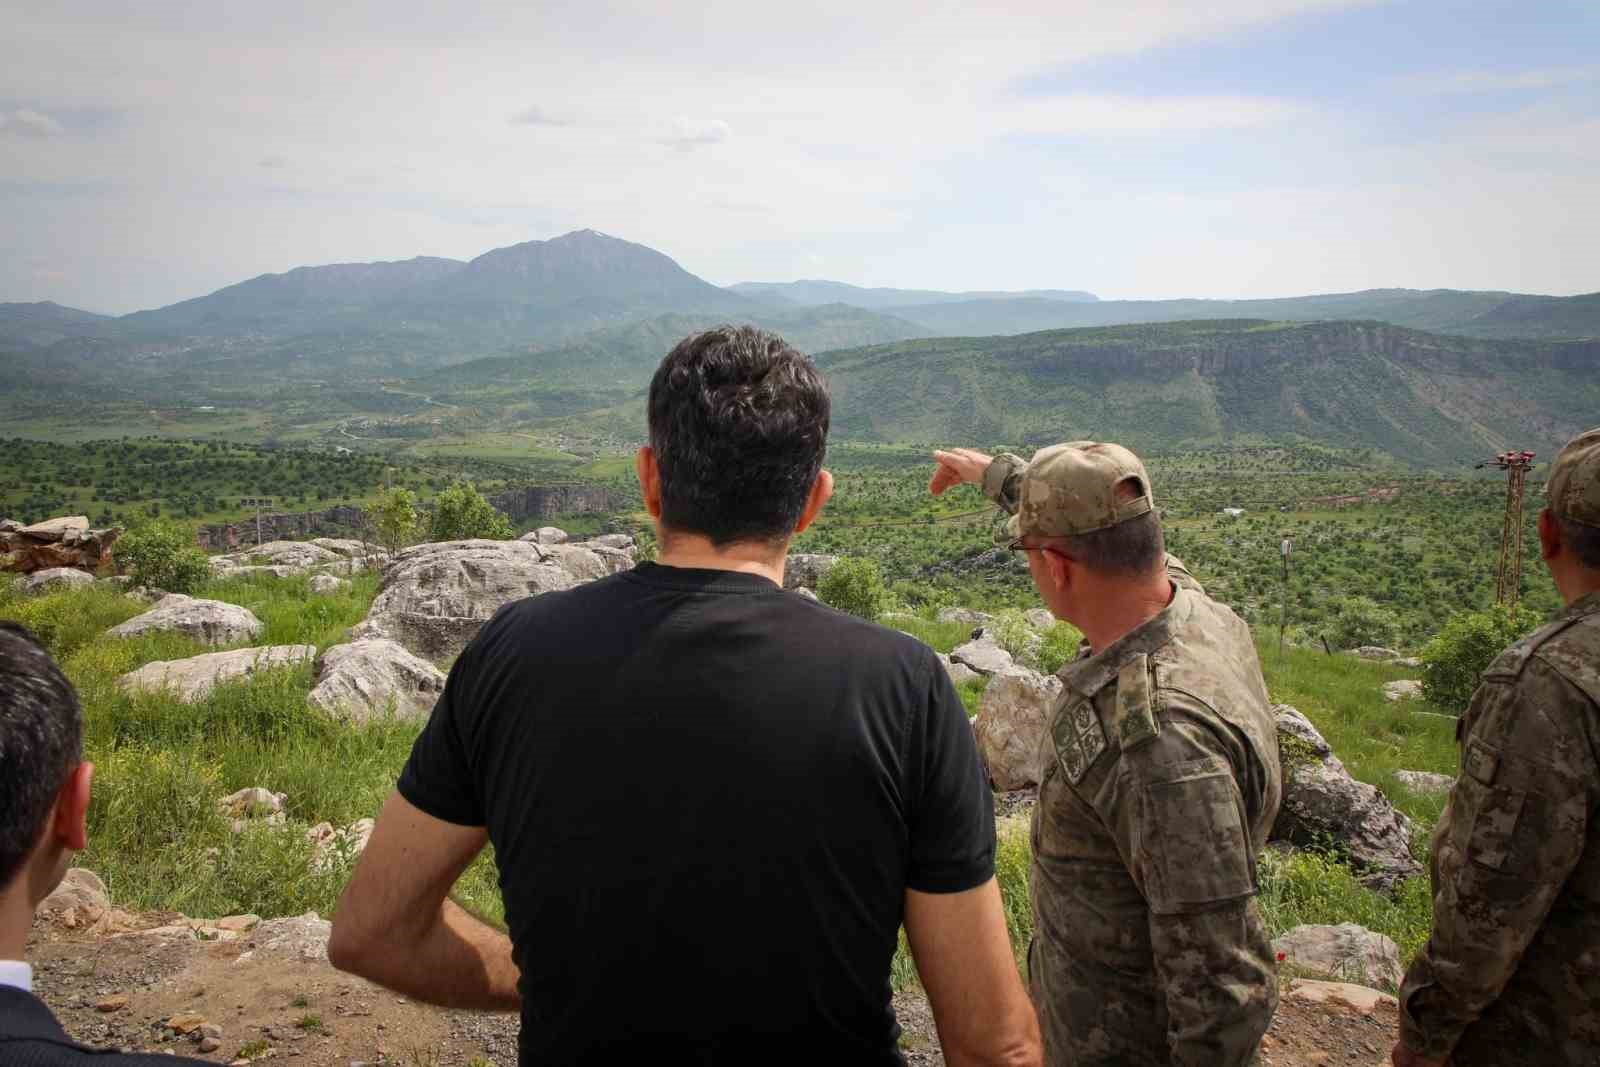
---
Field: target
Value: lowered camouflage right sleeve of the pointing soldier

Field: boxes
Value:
[1104,720,1277,1067]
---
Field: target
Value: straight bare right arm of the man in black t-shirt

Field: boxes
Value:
[906,878,1043,1067]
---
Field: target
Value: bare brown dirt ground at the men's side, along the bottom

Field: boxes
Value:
[29,915,1395,1067]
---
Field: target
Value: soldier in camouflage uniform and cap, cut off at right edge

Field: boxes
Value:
[1394,429,1600,1067]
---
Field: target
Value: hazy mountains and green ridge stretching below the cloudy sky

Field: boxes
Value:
[0,230,1600,464]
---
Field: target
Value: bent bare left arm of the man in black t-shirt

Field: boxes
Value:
[328,792,522,1011]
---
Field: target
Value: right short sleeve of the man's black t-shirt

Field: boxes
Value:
[906,656,995,893]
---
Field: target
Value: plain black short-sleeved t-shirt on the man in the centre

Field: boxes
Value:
[398,563,995,1064]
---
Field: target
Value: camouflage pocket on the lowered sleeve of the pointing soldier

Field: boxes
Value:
[1141,760,1256,915]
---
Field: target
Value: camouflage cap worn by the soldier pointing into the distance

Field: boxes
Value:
[1006,442,1155,539]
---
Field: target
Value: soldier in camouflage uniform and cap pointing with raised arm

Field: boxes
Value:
[930,442,1282,1067]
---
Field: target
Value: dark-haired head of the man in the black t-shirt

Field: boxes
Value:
[638,326,832,561]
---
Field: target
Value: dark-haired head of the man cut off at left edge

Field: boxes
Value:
[0,622,94,960]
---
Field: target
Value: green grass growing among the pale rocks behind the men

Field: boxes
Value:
[0,576,1454,981]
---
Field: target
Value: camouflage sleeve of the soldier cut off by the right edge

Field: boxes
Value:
[1400,657,1595,1057]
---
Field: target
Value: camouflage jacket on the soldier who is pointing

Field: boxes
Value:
[1029,584,1282,1067]
